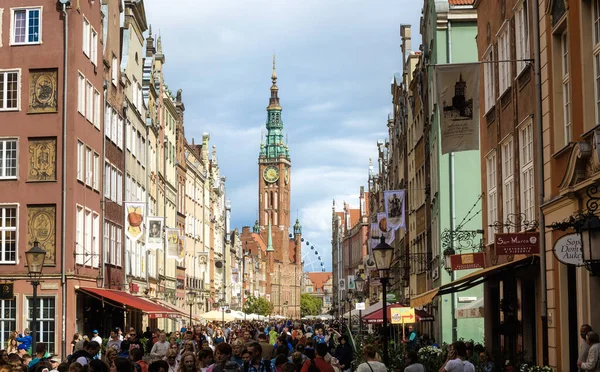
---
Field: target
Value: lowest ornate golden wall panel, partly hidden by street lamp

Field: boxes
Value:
[27,205,56,266]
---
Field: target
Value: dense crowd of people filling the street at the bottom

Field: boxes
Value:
[0,321,387,372]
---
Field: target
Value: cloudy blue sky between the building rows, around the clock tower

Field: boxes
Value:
[144,0,423,271]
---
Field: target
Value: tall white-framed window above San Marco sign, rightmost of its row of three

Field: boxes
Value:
[519,122,535,225]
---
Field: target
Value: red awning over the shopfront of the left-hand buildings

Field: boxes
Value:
[79,288,181,319]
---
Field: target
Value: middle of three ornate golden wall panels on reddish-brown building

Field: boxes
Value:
[27,138,56,182]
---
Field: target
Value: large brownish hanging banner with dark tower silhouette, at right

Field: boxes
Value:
[435,63,480,154]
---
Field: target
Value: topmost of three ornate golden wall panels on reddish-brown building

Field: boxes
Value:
[29,69,58,114]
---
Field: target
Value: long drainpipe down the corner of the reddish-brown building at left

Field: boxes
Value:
[60,2,69,359]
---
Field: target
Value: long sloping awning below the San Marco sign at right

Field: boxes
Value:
[410,256,538,307]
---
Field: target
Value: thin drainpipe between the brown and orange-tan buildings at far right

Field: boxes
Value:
[532,0,548,366]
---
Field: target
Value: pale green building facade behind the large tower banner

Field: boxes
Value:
[421,0,484,344]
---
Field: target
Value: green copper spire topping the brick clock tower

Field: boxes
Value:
[260,55,290,160]
